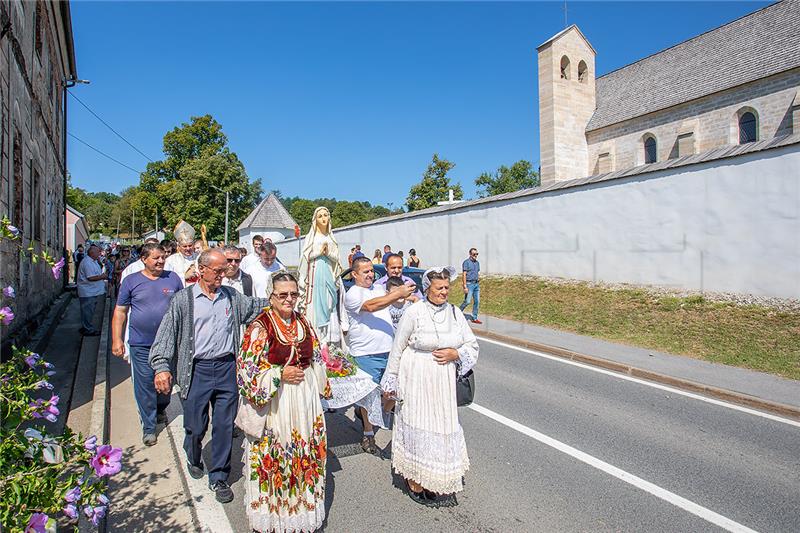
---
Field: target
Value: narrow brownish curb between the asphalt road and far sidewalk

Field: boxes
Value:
[472,329,800,420]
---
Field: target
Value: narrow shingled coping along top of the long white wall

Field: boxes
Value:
[282,133,800,242]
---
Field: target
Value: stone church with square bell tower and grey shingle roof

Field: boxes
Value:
[538,0,800,185]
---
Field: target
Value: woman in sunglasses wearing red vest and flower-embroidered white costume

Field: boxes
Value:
[237,272,329,532]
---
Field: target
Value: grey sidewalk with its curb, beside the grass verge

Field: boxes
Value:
[472,315,800,418]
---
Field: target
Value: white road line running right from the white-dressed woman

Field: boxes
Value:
[469,403,755,533]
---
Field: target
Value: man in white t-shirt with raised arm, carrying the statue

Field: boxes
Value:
[344,257,414,454]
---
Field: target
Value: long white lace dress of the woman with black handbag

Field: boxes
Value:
[381,300,478,494]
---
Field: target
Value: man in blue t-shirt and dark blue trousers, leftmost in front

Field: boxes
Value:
[111,243,183,446]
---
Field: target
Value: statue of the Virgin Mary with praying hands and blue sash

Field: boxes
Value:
[297,206,344,343]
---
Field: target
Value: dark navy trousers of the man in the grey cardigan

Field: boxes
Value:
[183,355,239,483]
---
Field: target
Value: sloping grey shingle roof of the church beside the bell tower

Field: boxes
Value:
[586,0,800,131]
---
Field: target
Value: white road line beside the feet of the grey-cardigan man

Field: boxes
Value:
[166,402,233,533]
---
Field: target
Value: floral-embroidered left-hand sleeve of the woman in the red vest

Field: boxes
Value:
[236,318,283,407]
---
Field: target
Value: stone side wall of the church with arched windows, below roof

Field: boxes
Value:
[574,69,800,174]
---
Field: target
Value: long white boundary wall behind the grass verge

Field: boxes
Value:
[276,144,800,298]
